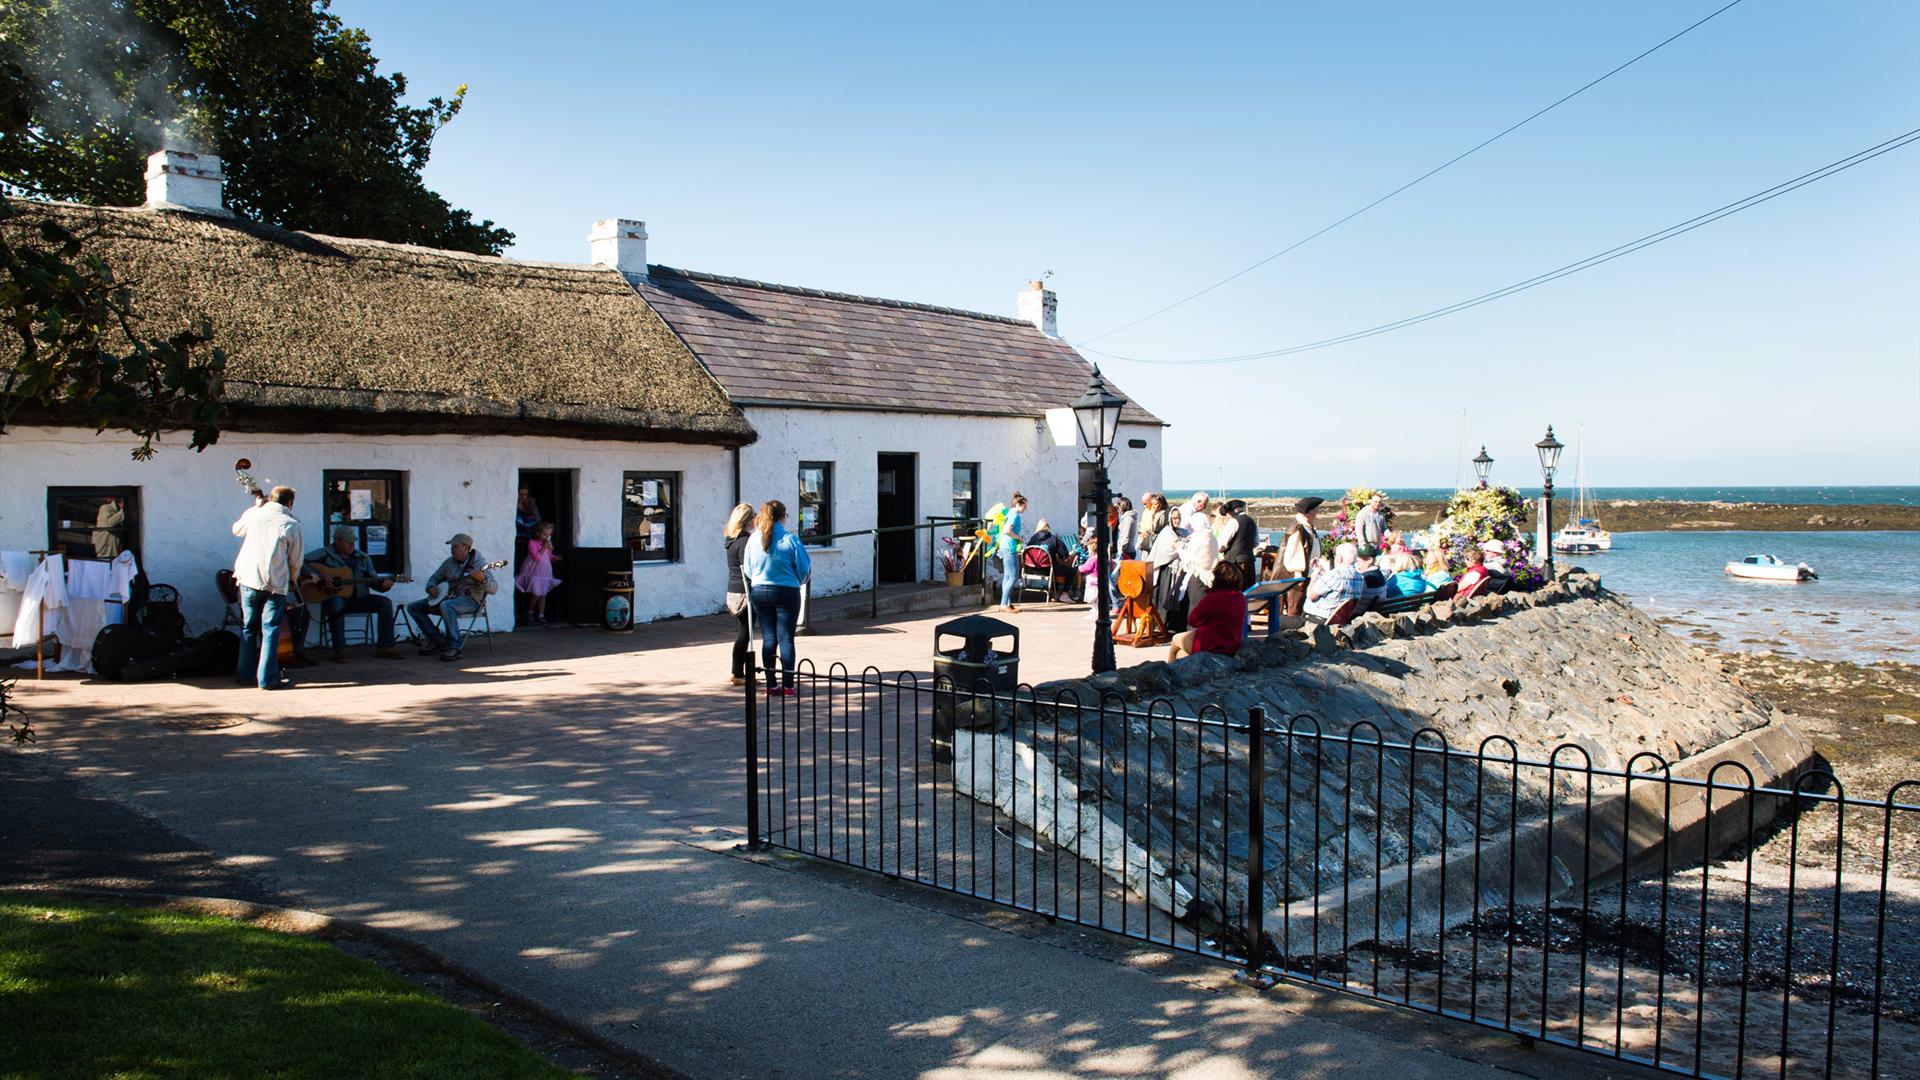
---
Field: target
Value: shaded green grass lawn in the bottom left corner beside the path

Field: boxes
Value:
[0,901,572,1080]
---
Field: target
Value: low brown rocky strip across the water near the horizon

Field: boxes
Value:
[1246,498,1920,532]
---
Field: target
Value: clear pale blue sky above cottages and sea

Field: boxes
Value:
[334,0,1920,486]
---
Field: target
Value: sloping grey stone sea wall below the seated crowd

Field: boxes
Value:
[954,571,1799,922]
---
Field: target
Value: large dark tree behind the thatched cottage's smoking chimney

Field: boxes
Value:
[0,0,513,254]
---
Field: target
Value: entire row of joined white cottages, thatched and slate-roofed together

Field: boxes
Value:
[0,152,1164,641]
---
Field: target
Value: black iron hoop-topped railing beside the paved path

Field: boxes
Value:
[745,661,1920,1076]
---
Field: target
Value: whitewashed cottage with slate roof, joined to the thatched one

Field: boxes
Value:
[593,221,1165,594]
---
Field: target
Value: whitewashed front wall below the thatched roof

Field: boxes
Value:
[0,427,733,630]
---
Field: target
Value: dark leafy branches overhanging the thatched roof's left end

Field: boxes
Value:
[0,61,227,461]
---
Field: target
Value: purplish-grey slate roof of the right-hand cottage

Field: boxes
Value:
[634,265,1162,425]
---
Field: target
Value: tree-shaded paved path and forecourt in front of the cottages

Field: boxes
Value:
[0,611,1651,1080]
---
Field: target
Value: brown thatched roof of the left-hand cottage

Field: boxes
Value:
[4,204,755,446]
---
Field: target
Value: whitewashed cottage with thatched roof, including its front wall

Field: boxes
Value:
[0,156,753,628]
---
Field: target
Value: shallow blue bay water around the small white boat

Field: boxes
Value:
[1555,532,1920,663]
